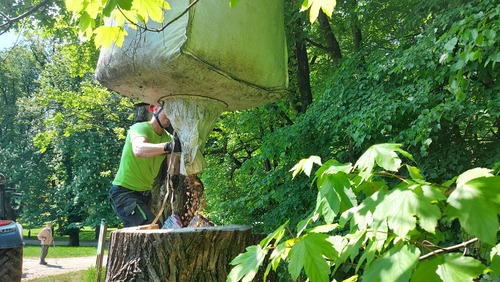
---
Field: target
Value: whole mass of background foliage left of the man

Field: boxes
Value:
[0,38,132,235]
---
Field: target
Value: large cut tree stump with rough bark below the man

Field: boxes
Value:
[106,225,270,282]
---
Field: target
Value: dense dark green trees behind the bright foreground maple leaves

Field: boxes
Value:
[202,1,500,242]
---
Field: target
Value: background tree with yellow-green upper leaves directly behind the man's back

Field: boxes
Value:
[22,40,132,245]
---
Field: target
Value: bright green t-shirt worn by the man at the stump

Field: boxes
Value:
[113,122,172,191]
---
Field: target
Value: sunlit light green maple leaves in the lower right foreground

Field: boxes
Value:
[228,144,500,281]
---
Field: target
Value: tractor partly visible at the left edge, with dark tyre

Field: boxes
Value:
[0,173,24,281]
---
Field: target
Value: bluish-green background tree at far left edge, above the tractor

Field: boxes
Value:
[0,43,49,228]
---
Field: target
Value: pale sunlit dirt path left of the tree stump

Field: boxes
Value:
[21,256,107,281]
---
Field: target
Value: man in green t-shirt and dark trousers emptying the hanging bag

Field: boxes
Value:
[109,103,181,227]
